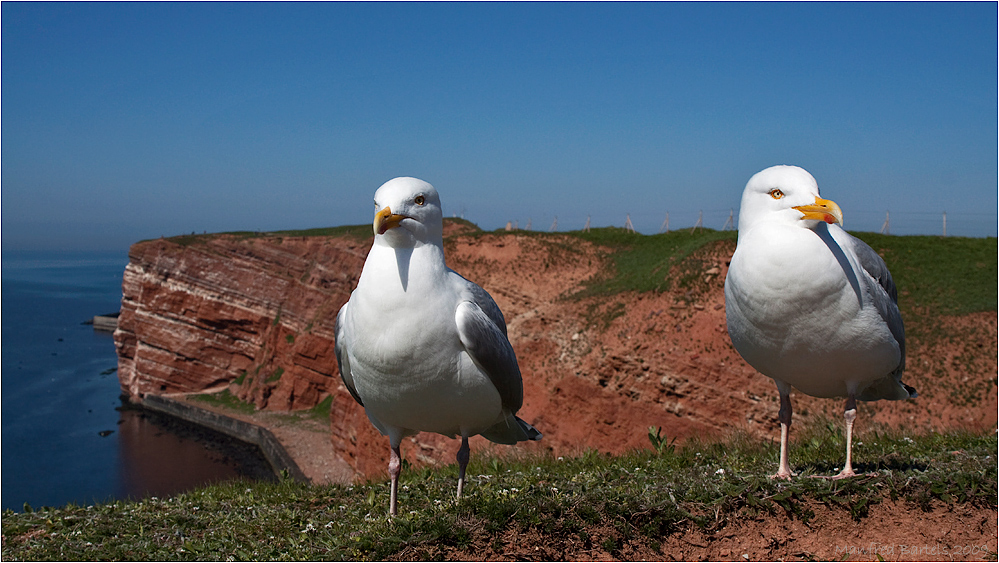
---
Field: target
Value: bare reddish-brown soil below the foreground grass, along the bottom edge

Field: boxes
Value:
[396,501,997,561]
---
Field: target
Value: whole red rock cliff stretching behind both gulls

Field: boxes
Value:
[115,225,997,480]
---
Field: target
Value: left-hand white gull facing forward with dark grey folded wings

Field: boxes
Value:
[335,178,541,515]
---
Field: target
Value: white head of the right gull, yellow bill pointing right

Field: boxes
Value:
[739,166,843,231]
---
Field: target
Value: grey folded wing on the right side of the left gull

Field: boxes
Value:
[454,278,524,413]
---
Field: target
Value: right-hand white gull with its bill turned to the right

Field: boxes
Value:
[725,166,916,479]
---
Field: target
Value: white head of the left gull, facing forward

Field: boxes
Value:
[373,177,444,248]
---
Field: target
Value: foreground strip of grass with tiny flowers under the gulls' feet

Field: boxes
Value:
[2,430,997,560]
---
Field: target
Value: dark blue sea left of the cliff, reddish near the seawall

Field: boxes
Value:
[0,251,273,512]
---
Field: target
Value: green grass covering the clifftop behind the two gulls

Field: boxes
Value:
[158,217,999,316]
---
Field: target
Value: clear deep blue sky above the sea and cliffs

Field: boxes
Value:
[0,2,999,251]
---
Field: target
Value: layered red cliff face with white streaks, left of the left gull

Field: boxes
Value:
[115,229,370,410]
